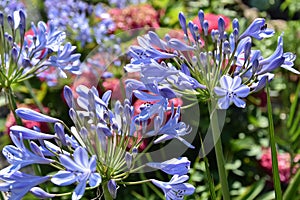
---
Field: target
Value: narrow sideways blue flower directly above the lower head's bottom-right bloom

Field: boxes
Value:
[146,157,191,176]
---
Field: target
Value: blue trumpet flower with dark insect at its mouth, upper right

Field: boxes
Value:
[239,18,274,40]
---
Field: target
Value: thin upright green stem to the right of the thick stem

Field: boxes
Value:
[267,81,282,200]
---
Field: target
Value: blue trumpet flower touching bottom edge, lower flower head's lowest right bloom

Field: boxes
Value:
[151,174,195,200]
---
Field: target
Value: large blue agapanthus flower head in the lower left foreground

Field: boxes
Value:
[0,82,195,199]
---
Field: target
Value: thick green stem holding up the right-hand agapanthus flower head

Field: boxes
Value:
[209,100,230,200]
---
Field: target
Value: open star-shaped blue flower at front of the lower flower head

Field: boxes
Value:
[51,147,102,200]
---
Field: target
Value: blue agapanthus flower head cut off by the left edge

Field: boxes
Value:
[0,10,80,89]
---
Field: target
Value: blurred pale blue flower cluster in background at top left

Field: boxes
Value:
[45,0,115,47]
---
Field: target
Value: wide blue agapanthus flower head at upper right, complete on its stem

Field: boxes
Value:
[125,10,299,109]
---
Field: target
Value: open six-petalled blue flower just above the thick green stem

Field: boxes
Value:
[214,75,250,109]
